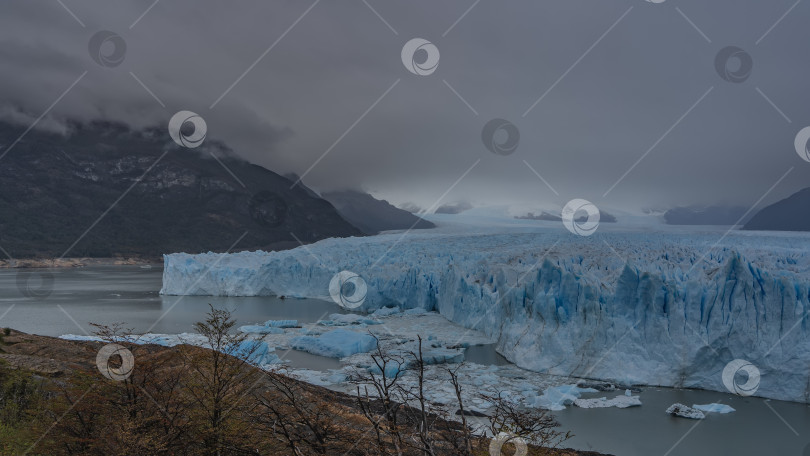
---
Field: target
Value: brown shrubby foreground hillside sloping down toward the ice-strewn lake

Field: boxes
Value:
[0,320,608,456]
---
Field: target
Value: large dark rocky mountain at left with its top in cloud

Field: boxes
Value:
[0,123,361,258]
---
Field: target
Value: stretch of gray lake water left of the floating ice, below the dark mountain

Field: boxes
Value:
[0,266,346,336]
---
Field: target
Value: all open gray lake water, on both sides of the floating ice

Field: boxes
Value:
[0,266,810,456]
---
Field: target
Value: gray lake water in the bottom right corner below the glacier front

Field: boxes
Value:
[554,388,810,456]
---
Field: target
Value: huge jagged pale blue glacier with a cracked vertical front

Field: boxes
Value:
[161,215,810,402]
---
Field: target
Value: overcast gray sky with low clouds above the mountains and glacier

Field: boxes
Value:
[0,0,810,214]
